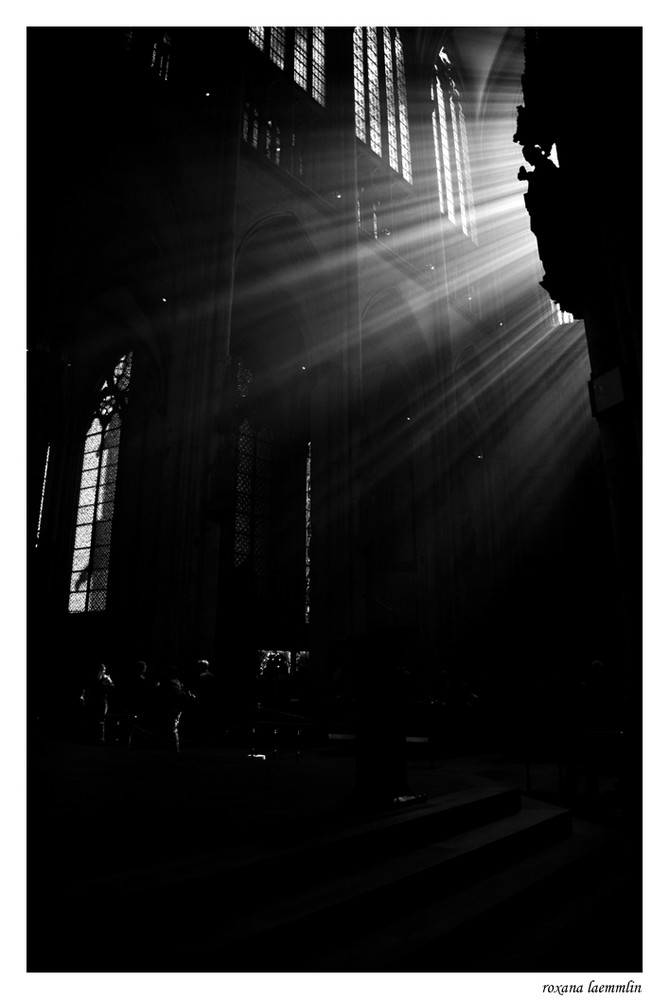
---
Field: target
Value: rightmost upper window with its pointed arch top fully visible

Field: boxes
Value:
[431,49,477,243]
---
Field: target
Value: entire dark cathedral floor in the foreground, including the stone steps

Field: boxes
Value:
[28,717,641,972]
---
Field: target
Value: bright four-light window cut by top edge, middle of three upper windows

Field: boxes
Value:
[354,28,412,183]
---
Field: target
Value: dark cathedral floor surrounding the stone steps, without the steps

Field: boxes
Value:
[28,740,641,971]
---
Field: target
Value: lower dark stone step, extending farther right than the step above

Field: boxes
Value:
[176,804,571,971]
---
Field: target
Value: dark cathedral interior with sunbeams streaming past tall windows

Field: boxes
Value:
[26,27,642,972]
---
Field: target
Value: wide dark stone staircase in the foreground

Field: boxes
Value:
[71,785,607,972]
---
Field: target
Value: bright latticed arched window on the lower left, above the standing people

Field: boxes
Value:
[68,352,132,612]
